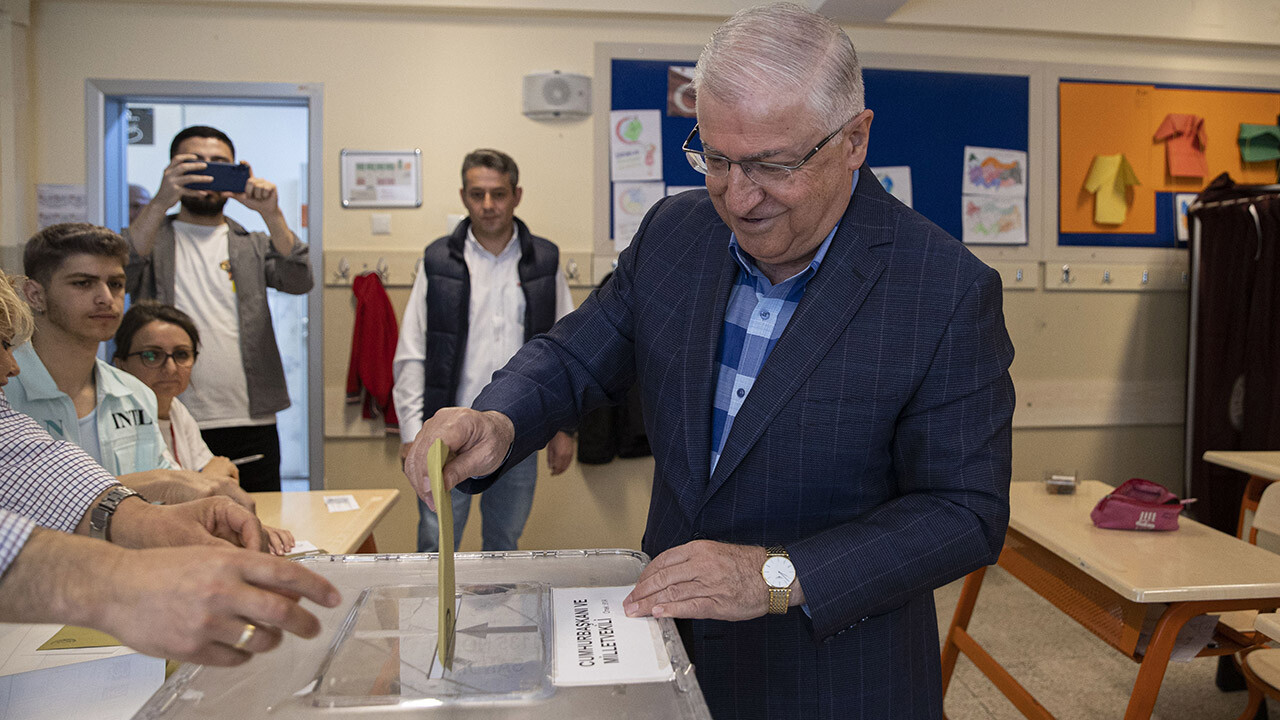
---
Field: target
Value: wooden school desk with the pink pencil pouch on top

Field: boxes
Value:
[942,480,1280,720]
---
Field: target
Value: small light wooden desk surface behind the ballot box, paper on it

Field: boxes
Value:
[250,488,399,555]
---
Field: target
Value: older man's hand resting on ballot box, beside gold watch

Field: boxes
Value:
[623,541,803,620]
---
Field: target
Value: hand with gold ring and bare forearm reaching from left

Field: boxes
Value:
[0,527,342,665]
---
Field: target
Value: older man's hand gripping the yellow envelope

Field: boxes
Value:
[404,407,516,510]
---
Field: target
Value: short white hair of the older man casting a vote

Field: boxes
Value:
[694,3,865,129]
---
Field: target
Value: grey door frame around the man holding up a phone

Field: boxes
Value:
[84,78,324,489]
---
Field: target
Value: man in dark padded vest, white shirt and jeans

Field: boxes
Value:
[393,149,573,552]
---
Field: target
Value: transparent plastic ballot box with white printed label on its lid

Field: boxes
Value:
[134,550,710,720]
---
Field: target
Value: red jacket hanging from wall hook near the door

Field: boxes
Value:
[347,273,399,434]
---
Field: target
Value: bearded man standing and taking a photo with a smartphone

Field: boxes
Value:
[123,126,312,492]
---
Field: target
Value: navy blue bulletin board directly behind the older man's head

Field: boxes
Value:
[609,59,1034,243]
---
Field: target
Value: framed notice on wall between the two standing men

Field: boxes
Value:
[342,149,422,208]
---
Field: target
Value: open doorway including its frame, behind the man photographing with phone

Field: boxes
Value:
[86,79,324,491]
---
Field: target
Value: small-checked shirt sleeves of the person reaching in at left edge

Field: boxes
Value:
[0,392,119,574]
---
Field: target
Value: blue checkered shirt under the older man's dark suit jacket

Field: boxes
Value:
[710,221,839,473]
